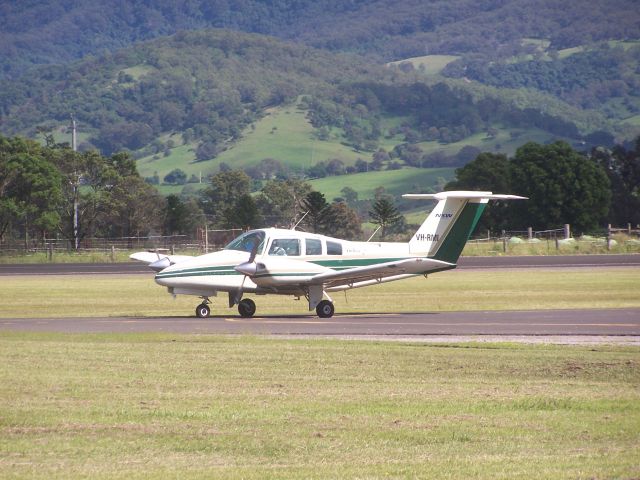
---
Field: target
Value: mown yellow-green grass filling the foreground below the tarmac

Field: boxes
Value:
[0,333,640,479]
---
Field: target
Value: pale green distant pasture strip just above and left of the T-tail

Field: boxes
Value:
[309,168,454,201]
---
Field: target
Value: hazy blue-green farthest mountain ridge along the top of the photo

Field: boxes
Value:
[0,0,640,76]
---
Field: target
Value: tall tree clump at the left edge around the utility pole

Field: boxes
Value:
[0,136,165,244]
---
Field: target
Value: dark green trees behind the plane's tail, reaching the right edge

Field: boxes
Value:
[446,137,640,233]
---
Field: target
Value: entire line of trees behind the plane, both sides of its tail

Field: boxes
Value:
[0,137,640,248]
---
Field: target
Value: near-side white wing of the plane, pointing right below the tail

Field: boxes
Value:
[305,257,455,287]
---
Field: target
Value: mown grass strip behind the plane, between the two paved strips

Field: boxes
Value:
[0,267,640,318]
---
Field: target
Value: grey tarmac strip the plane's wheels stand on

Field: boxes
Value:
[0,309,640,337]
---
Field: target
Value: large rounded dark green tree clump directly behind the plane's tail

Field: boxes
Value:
[446,142,612,233]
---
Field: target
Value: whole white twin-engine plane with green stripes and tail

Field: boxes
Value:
[131,191,525,318]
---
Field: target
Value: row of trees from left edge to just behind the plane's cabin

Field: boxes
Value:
[0,136,362,246]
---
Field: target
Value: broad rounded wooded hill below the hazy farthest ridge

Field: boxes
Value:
[0,30,604,166]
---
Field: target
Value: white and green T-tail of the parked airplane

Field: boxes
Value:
[403,191,526,264]
